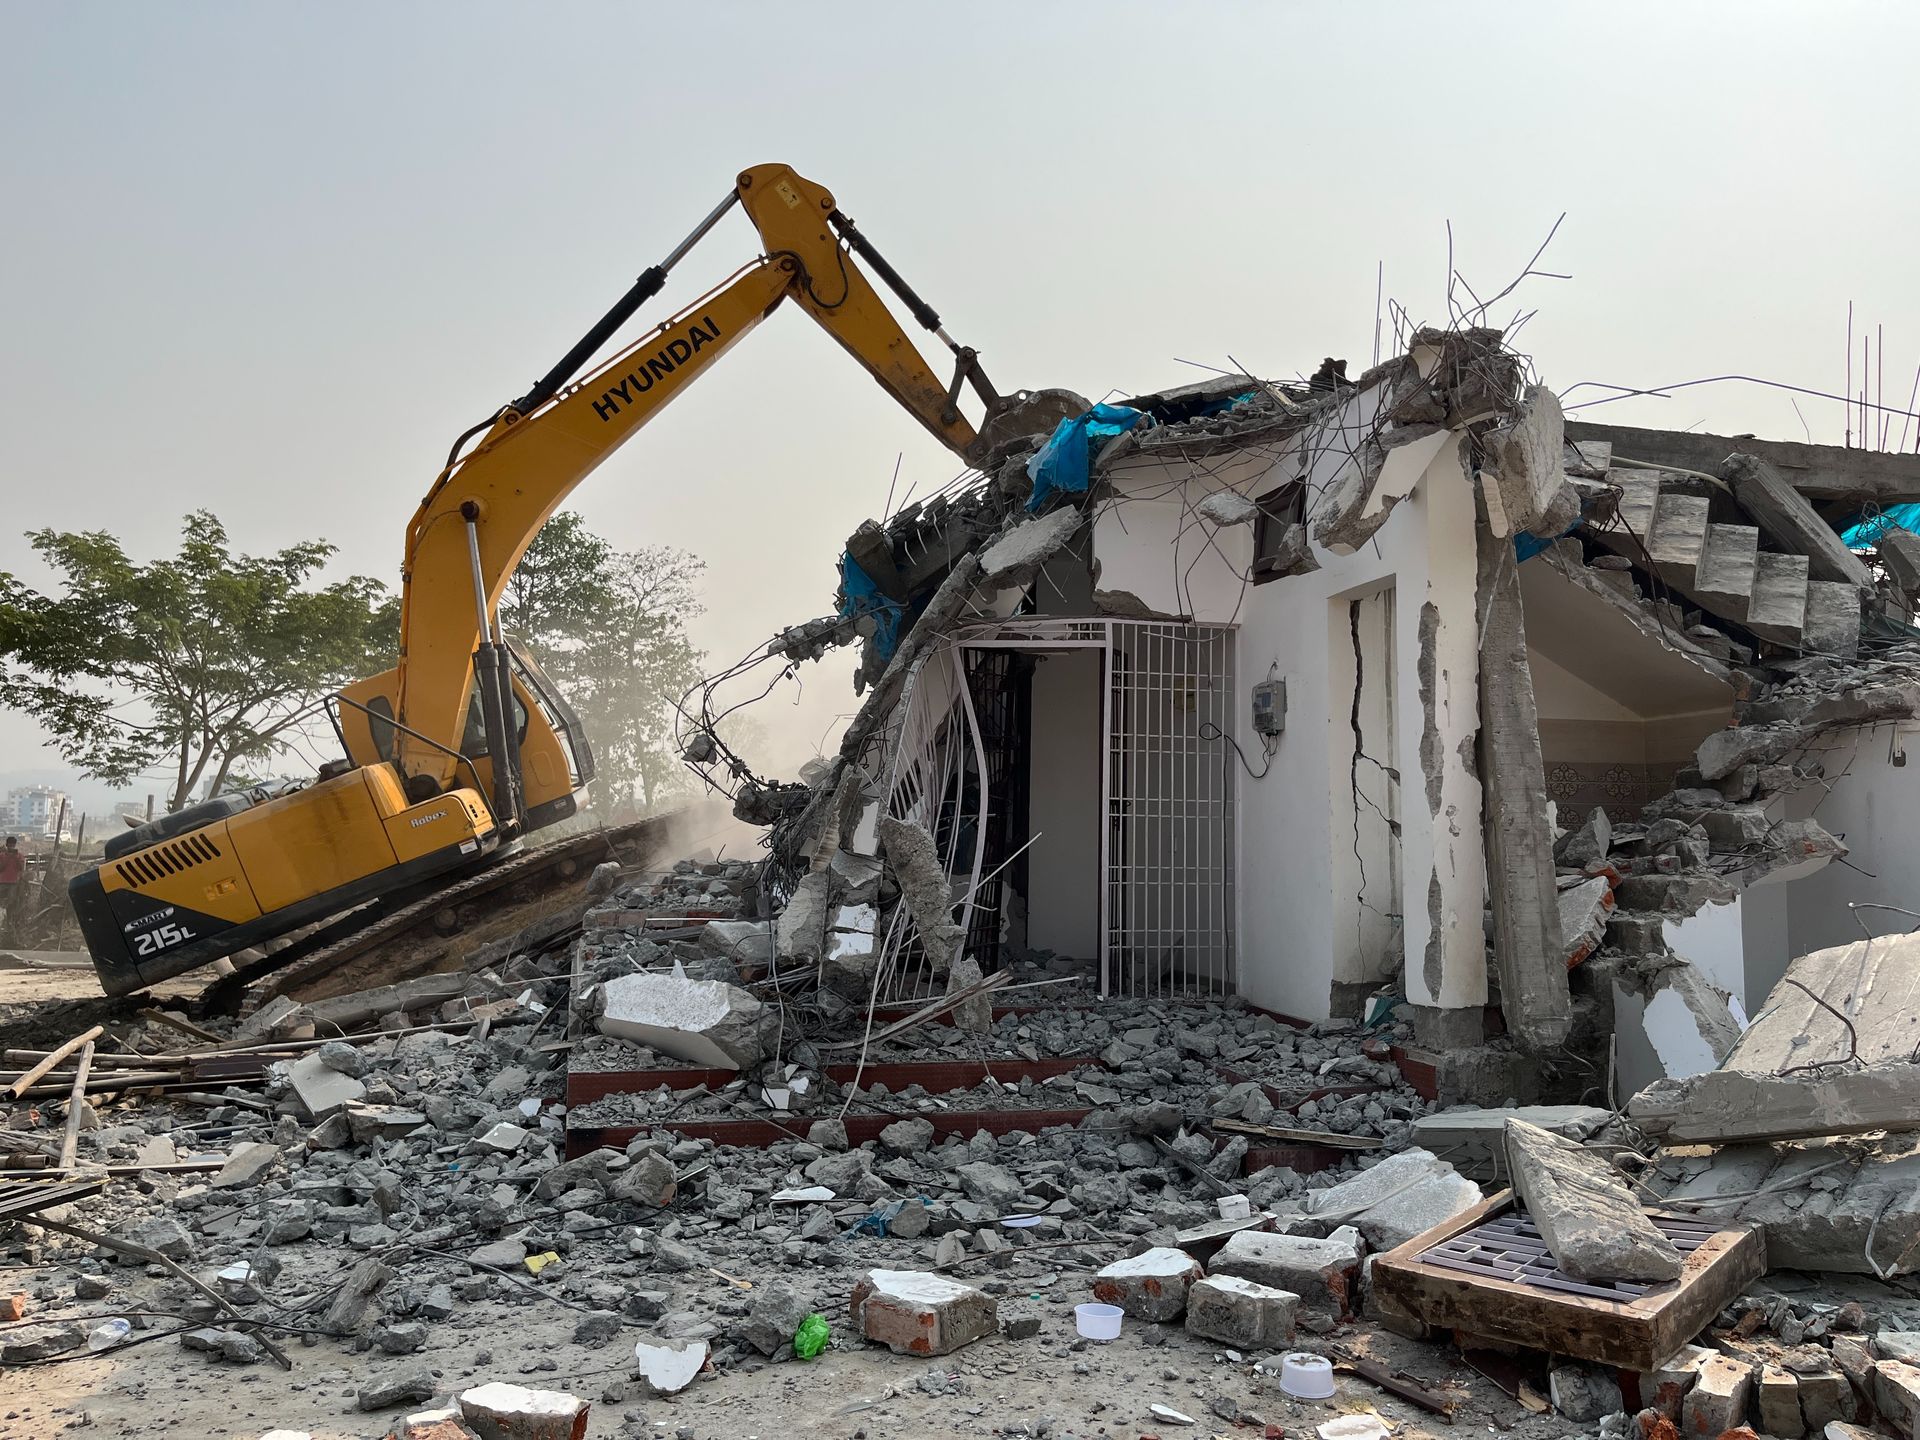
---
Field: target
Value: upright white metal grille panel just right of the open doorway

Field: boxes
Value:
[1100,620,1235,996]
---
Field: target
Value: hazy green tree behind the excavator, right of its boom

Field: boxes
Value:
[499,511,707,814]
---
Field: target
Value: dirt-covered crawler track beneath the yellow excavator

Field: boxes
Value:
[223,814,676,1016]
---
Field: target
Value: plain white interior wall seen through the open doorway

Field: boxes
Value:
[1027,651,1100,960]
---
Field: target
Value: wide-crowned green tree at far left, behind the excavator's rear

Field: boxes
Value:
[0,511,399,810]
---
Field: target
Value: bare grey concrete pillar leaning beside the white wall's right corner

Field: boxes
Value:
[1476,485,1572,1050]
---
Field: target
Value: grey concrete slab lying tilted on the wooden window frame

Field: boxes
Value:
[1507,1119,1682,1281]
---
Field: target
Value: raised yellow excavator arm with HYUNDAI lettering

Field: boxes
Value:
[396,165,1002,794]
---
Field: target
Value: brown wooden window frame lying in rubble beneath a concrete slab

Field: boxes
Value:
[1373,1190,1766,1371]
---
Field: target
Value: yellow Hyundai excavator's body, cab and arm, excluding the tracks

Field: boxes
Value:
[69,165,1052,995]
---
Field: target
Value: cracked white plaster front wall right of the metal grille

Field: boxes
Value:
[1092,392,1486,1020]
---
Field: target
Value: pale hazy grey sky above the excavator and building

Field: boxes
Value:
[0,0,1920,806]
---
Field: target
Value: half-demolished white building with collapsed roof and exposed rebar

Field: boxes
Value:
[687,328,1920,1102]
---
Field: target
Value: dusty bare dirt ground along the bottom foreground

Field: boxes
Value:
[0,1279,1578,1440]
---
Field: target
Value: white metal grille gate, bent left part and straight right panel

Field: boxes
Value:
[877,618,1236,1004]
